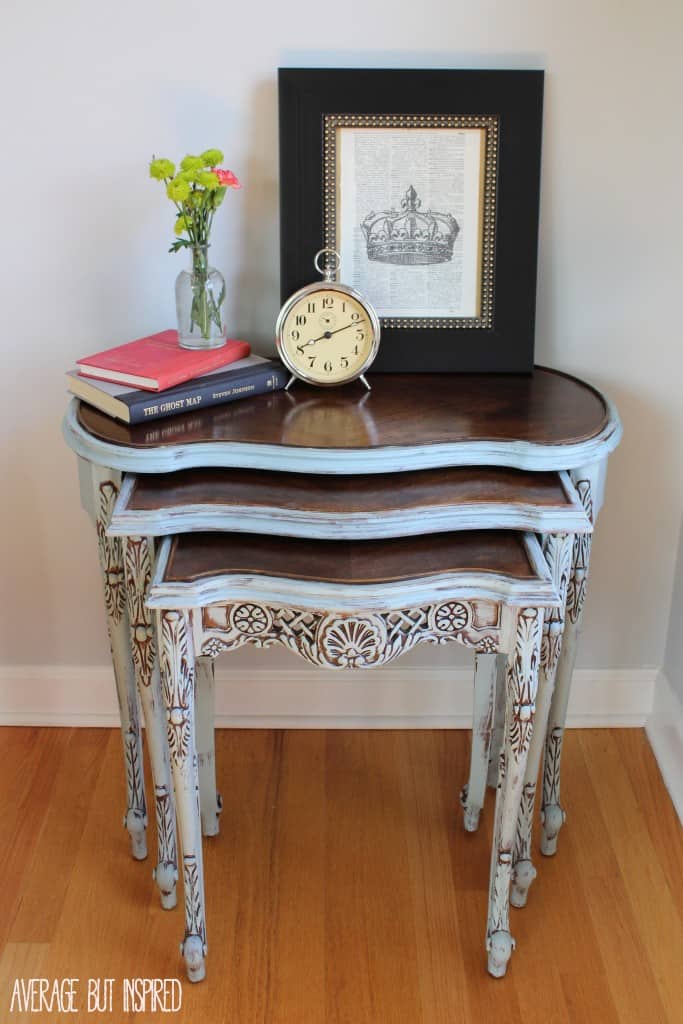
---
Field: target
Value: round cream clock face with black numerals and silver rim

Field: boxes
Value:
[278,284,380,384]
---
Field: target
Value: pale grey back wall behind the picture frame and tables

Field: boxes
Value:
[0,0,683,668]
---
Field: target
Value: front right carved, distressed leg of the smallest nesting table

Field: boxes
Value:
[486,608,543,978]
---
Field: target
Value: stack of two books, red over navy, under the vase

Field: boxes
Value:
[67,331,288,424]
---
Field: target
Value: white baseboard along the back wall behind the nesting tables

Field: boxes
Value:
[0,664,658,729]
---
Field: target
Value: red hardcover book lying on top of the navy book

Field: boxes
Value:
[76,331,251,391]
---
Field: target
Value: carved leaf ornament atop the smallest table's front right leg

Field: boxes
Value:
[508,608,543,760]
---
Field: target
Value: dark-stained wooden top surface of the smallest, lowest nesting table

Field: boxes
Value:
[164,530,536,584]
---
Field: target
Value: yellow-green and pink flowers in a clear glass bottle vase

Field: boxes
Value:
[150,150,241,348]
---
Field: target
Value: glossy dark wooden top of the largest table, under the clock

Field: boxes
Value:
[78,367,609,450]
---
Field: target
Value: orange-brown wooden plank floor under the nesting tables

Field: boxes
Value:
[0,728,683,1024]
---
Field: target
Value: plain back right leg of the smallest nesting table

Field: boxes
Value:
[460,653,497,831]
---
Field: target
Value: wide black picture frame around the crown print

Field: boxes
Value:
[279,68,544,373]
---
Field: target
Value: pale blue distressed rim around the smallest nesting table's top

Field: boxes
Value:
[147,534,556,612]
